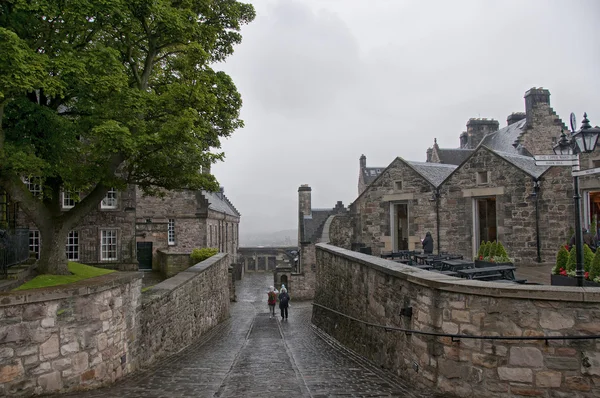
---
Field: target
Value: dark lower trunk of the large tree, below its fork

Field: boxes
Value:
[37,225,71,275]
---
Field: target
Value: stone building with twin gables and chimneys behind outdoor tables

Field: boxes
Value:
[342,88,600,264]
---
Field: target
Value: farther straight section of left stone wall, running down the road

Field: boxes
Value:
[136,253,230,366]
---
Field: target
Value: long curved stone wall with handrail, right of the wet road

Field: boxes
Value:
[313,244,600,398]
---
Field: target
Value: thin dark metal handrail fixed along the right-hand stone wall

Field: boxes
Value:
[312,303,600,344]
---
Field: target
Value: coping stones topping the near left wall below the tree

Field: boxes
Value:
[0,272,142,308]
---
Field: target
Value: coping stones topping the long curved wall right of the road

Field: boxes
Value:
[316,243,600,303]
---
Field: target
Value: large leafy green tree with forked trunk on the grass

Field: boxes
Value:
[0,0,255,274]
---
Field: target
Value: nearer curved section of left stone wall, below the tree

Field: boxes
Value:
[0,273,142,396]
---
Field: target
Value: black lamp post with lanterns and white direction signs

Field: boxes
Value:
[553,113,600,286]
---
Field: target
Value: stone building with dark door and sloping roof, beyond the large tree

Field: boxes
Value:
[136,188,240,270]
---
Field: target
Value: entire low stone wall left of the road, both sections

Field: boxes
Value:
[0,254,231,397]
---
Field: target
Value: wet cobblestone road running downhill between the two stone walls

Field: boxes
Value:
[61,274,432,398]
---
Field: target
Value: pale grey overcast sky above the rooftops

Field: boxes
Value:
[213,0,600,235]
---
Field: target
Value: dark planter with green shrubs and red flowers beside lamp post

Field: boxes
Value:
[550,244,600,287]
